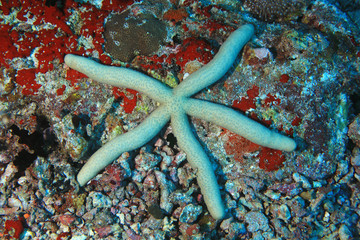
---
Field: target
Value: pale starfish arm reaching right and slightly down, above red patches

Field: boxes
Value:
[184,99,296,151]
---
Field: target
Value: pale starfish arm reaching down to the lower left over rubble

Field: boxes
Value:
[77,107,170,186]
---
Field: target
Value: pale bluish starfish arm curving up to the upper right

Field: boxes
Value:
[174,24,254,97]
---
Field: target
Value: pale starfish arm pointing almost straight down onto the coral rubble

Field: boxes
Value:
[171,111,225,219]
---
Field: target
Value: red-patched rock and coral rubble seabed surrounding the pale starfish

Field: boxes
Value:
[0,0,360,240]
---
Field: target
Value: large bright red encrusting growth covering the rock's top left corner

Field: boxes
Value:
[0,0,134,95]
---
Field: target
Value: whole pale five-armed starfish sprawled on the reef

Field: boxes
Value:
[65,24,296,219]
